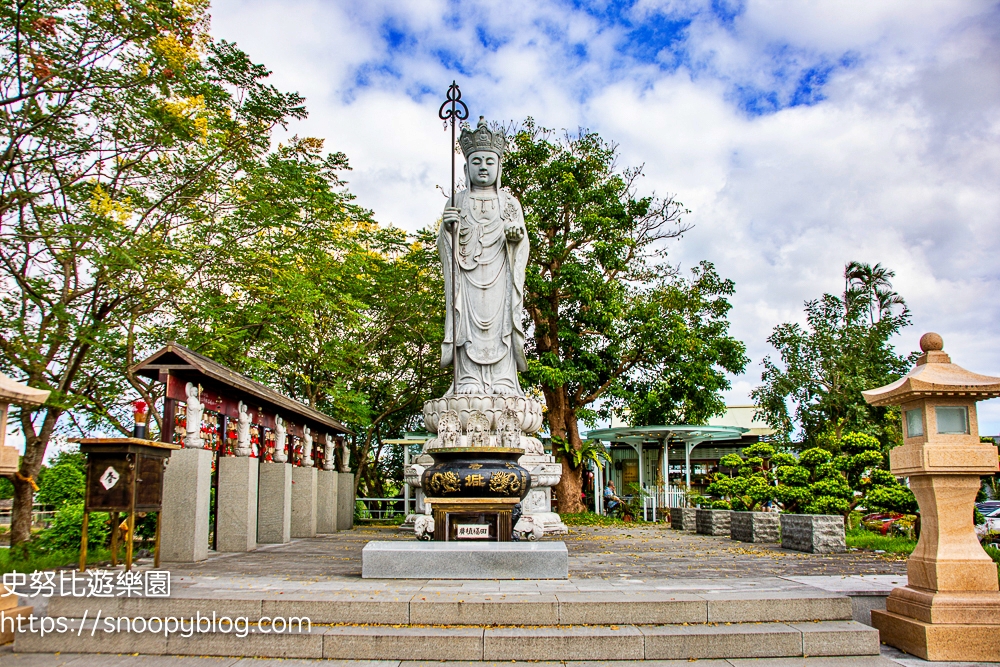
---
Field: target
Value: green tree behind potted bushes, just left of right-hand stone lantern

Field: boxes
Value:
[751,262,912,449]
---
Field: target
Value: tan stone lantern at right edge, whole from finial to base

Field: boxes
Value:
[863,333,1000,661]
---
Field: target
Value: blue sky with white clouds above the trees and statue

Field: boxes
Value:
[213,0,1000,434]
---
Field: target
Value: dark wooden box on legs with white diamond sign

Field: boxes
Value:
[73,438,180,571]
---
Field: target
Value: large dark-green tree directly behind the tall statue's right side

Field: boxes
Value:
[502,118,747,512]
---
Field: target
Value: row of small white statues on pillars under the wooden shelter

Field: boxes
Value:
[184,382,350,472]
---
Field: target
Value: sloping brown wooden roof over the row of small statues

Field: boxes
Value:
[131,342,354,435]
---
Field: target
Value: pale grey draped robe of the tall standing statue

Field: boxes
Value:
[437,188,528,396]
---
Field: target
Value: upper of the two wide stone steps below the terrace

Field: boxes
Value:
[46,589,852,625]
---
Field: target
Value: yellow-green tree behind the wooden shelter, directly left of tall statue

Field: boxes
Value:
[176,138,447,496]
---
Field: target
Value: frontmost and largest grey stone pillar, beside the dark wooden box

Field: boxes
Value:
[159,449,213,563]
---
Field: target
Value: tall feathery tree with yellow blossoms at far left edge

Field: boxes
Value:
[0,0,304,545]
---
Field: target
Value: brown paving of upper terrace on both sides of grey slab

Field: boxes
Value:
[162,525,906,579]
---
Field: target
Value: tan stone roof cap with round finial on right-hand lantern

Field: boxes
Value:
[861,333,1000,406]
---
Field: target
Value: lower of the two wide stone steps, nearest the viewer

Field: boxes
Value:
[14,621,879,662]
